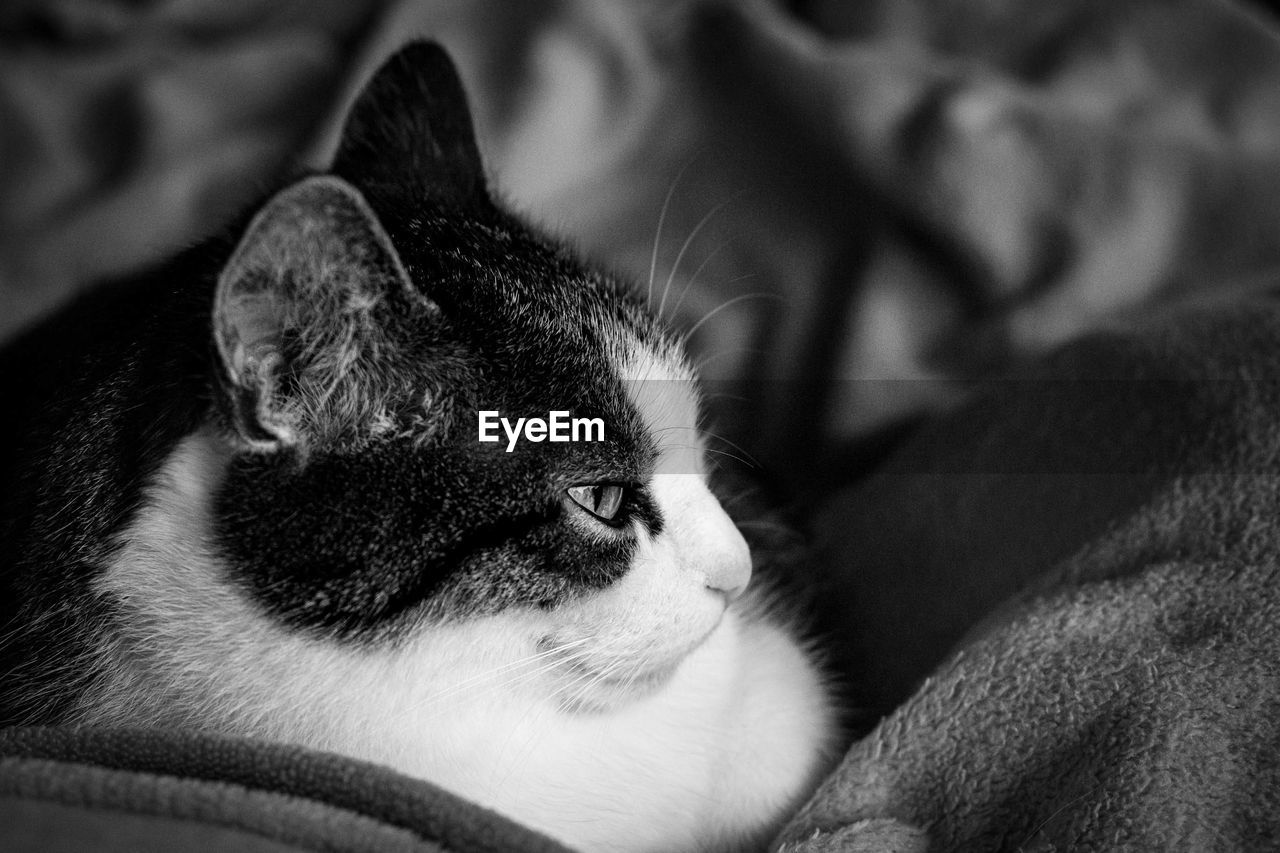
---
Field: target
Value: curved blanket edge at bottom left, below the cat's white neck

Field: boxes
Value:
[0,729,563,853]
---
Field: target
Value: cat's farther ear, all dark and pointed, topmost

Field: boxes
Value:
[332,41,489,205]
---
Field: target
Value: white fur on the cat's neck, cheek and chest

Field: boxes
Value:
[81,412,833,850]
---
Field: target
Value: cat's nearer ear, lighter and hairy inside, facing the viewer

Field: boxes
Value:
[214,175,422,450]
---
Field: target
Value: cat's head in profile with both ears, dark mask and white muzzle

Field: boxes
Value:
[193,44,750,707]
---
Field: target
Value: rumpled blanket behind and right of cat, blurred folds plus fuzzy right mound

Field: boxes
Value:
[0,0,1280,850]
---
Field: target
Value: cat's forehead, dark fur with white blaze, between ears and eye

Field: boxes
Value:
[363,197,701,476]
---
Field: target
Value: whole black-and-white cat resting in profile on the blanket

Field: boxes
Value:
[0,42,837,850]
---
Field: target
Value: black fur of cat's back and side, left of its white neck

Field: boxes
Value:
[0,250,217,722]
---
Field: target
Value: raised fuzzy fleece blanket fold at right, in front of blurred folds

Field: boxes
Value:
[786,297,1280,853]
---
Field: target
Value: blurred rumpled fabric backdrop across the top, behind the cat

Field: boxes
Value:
[0,0,1280,498]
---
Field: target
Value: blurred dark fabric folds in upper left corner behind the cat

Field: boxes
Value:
[0,0,380,336]
